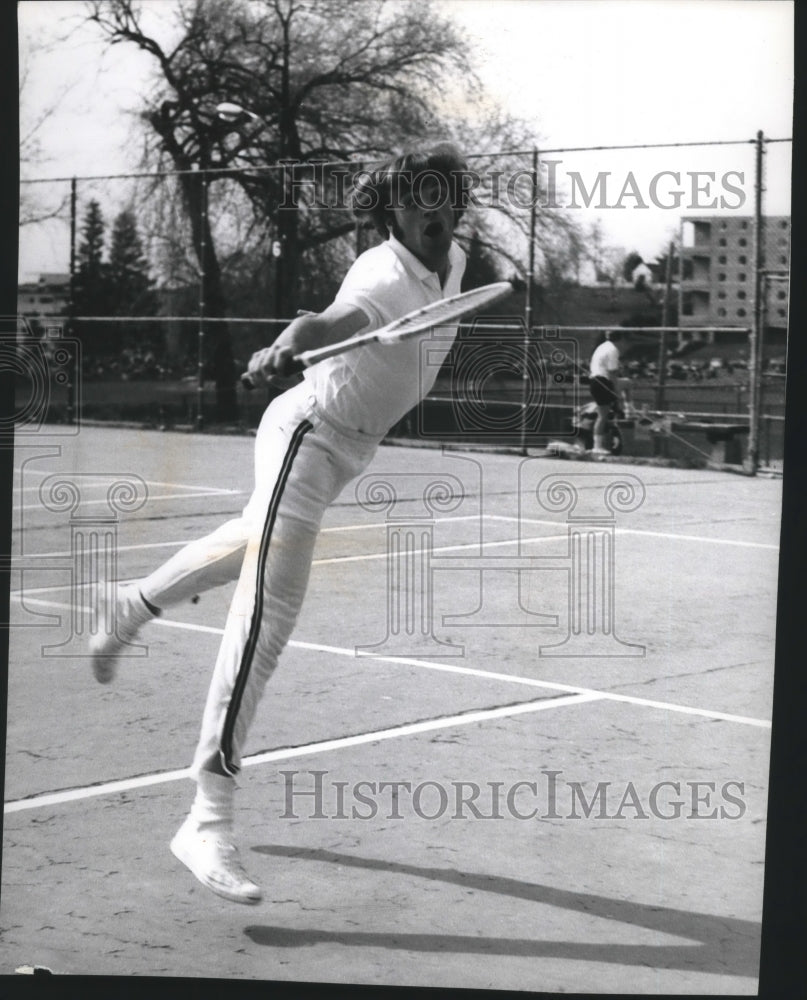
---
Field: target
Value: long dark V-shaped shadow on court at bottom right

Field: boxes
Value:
[245,845,760,977]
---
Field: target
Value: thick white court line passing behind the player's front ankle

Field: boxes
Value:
[3,694,597,815]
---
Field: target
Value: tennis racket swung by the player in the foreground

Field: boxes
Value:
[241,281,513,389]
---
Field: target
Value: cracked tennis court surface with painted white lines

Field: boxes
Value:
[0,427,781,994]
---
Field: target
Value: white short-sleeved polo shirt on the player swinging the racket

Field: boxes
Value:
[305,236,465,438]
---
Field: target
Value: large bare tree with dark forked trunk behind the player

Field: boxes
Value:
[89,0,471,416]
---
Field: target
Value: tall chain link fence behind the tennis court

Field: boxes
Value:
[17,134,790,471]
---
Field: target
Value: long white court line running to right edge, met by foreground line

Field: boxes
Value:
[13,595,771,729]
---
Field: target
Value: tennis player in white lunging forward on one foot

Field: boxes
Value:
[90,144,474,903]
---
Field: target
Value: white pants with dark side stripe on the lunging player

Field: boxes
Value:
[141,382,378,775]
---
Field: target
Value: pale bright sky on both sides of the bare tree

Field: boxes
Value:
[18,0,793,280]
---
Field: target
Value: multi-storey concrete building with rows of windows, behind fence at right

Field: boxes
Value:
[678,216,790,331]
